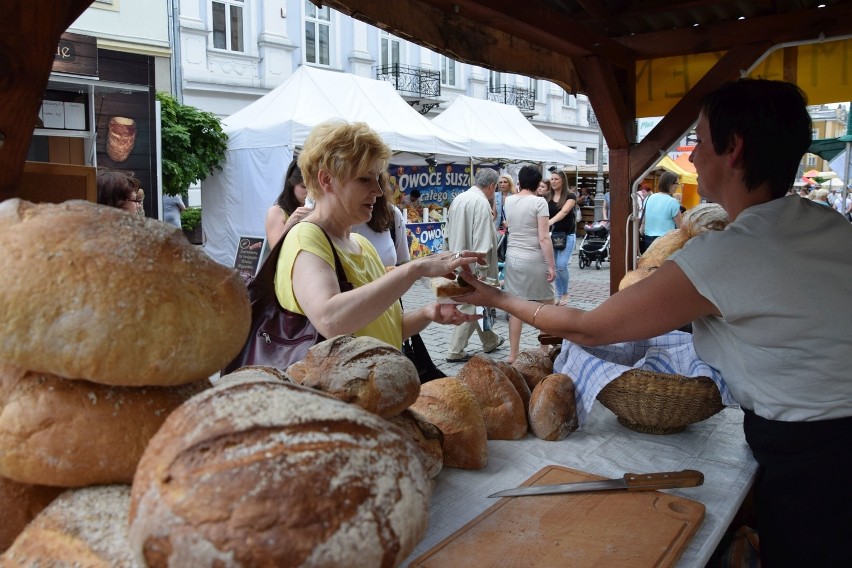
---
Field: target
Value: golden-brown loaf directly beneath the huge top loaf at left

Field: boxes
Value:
[0,365,210,487]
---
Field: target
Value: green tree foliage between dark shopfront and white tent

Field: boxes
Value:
[157,93,228,196]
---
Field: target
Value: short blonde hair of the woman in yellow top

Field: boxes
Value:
[299,120,393,199]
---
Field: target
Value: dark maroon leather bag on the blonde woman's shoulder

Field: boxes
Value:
[222,225,354,375]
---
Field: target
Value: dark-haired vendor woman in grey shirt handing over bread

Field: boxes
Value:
[458,79,852,568]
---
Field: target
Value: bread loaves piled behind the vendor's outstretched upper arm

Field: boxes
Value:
[618,203,728,290]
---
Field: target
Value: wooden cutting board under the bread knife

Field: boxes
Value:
[409,466,704,568]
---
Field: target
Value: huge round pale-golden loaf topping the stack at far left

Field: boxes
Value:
[0,199,251,386]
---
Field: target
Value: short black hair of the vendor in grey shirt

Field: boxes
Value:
[700,79,812,198]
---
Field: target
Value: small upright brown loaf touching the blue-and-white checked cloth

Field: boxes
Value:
[530,373,577,442]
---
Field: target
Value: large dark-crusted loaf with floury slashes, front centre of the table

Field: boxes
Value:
[129,374,431,568]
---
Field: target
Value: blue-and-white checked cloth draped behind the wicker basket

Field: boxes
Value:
[553,331,736,428]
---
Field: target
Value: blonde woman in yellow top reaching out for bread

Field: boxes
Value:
[275,122,485,348]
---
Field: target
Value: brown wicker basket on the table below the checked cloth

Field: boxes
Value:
[598,369,724,434]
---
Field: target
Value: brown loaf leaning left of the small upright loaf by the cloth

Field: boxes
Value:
[456,355,527,440]
